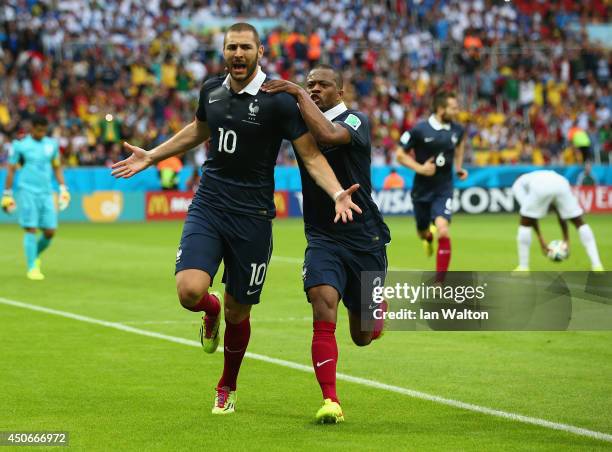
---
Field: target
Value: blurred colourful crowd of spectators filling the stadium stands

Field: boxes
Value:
[0,0,612,166]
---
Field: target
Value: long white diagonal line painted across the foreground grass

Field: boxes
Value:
[0,297,612,442]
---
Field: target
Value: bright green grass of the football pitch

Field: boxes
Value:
[0,215,612,450]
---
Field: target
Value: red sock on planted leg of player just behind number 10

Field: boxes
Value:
[312,320,338,402]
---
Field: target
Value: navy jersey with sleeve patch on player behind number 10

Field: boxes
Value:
[298,103,391,251]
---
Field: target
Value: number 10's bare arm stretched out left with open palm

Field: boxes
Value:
[111,119,210,179]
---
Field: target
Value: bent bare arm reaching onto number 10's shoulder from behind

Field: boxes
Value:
[262,80,351,145]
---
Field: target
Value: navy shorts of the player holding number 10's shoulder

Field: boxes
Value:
[302,237,387,314]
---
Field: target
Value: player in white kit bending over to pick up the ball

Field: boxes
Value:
[512,170,603,271]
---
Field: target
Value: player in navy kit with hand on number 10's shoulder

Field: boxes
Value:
[263,64,391,423]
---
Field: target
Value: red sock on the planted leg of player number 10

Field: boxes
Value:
[217,317,251,391]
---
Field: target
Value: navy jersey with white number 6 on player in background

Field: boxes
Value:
[400,115,464,200]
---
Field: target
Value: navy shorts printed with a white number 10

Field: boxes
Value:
[175,198,272,304]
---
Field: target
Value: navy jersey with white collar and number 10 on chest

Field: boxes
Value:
[196,69,308,218]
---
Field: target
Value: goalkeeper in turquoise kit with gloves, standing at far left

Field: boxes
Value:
[2,116,70,280]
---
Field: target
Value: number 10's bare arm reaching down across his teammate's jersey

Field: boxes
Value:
[293,133,361,223]
